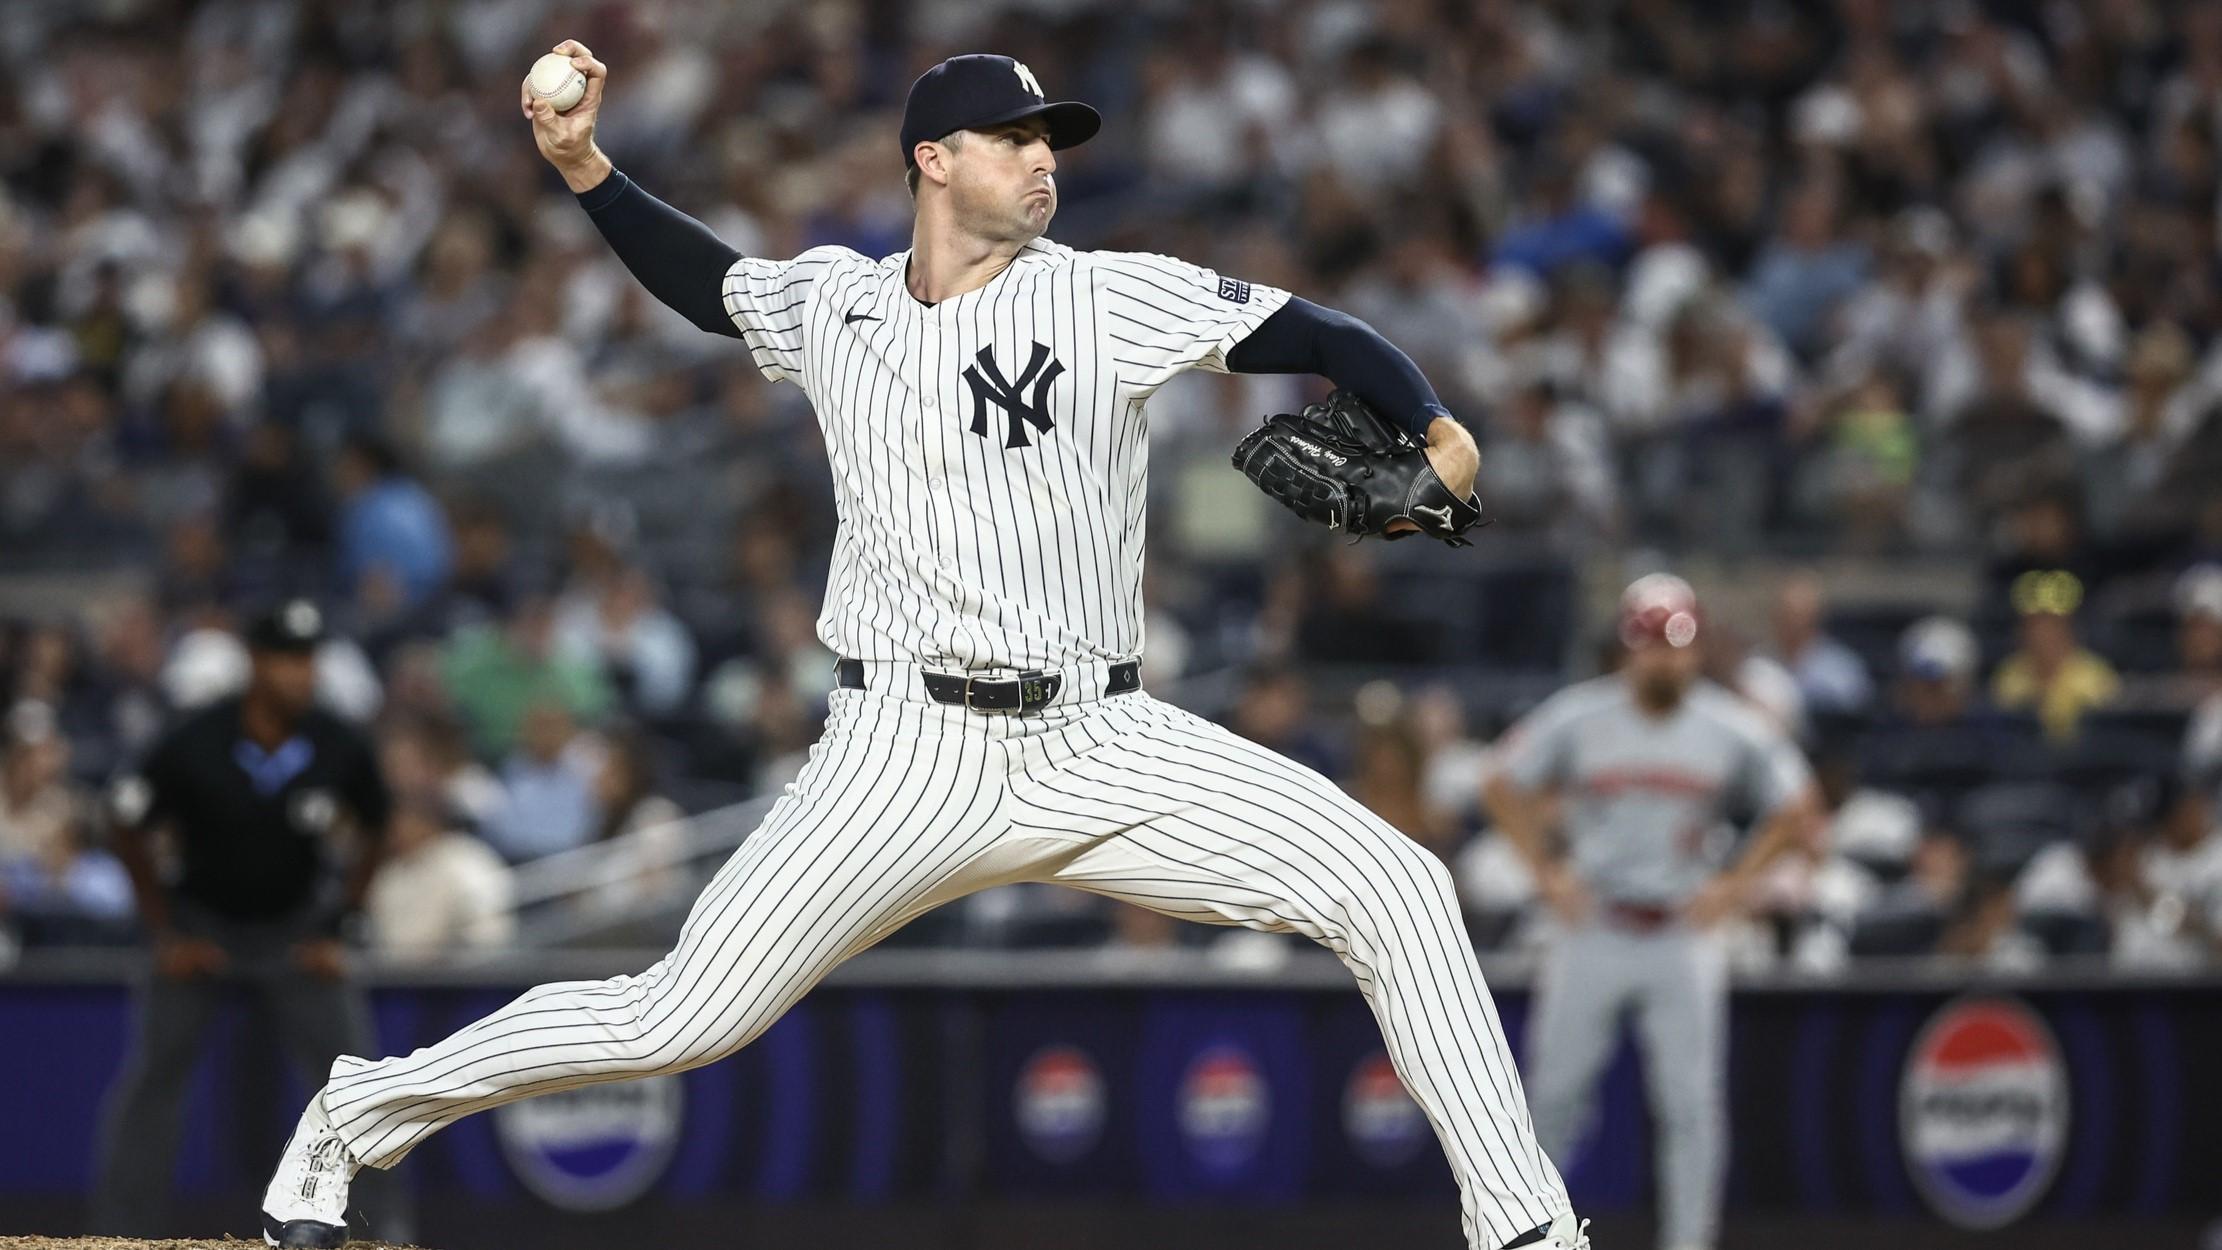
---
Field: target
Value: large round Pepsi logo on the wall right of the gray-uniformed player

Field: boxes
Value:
[1898,997,2069,1228]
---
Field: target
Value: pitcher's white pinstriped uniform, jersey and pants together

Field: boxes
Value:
[322,240,1567,1250]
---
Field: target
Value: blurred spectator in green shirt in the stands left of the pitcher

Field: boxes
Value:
[440,597,611,759]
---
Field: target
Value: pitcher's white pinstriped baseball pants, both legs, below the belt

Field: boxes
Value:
[322,688,1569,1250]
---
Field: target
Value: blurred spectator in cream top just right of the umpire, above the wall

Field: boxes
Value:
[362,797,516,961]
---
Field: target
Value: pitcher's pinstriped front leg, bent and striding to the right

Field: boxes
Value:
[1011,697,1569,1250]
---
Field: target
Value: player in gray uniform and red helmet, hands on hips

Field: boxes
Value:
[1484,573,1818,1250]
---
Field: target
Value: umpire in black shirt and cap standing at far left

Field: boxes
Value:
[93,599,398,1237]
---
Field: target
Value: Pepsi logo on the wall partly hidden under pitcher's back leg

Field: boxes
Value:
[493,1077,687,1210]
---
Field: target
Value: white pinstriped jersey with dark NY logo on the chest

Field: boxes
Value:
[724,240,1289,668]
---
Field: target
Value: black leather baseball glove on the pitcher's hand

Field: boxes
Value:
[1235,391,1489,546]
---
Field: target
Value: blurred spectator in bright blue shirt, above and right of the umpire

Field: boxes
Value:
[333,433,453,619]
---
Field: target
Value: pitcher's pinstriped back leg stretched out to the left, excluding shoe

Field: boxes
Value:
[322,693,1004,1168]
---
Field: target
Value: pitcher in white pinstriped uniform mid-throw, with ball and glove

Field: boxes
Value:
[262,40,1587,1250]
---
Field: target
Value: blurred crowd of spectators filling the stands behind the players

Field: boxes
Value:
[0,0,2222,968]
